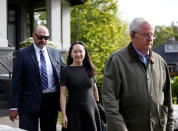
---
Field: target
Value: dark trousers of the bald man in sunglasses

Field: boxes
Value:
[19,93,59,131]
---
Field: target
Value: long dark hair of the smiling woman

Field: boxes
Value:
[67,41,96,77]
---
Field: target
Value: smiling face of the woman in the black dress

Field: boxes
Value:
[70,44,85,65]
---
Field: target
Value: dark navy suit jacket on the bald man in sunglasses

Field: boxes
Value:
[10,44,64,115]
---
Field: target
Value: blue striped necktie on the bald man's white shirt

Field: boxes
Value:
[40,50,48,89]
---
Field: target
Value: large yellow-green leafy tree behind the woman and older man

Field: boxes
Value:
[71,0,130,95]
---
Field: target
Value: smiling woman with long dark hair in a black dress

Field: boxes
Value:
[60,41,101,131]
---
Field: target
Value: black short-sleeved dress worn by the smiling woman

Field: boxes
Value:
[60,66,101,131]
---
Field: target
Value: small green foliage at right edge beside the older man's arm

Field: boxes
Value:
[171,77,178,102]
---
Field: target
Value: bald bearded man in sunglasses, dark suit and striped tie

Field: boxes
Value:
[9,26,65,131]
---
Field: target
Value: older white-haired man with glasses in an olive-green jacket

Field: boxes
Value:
[102,17,173,131]
